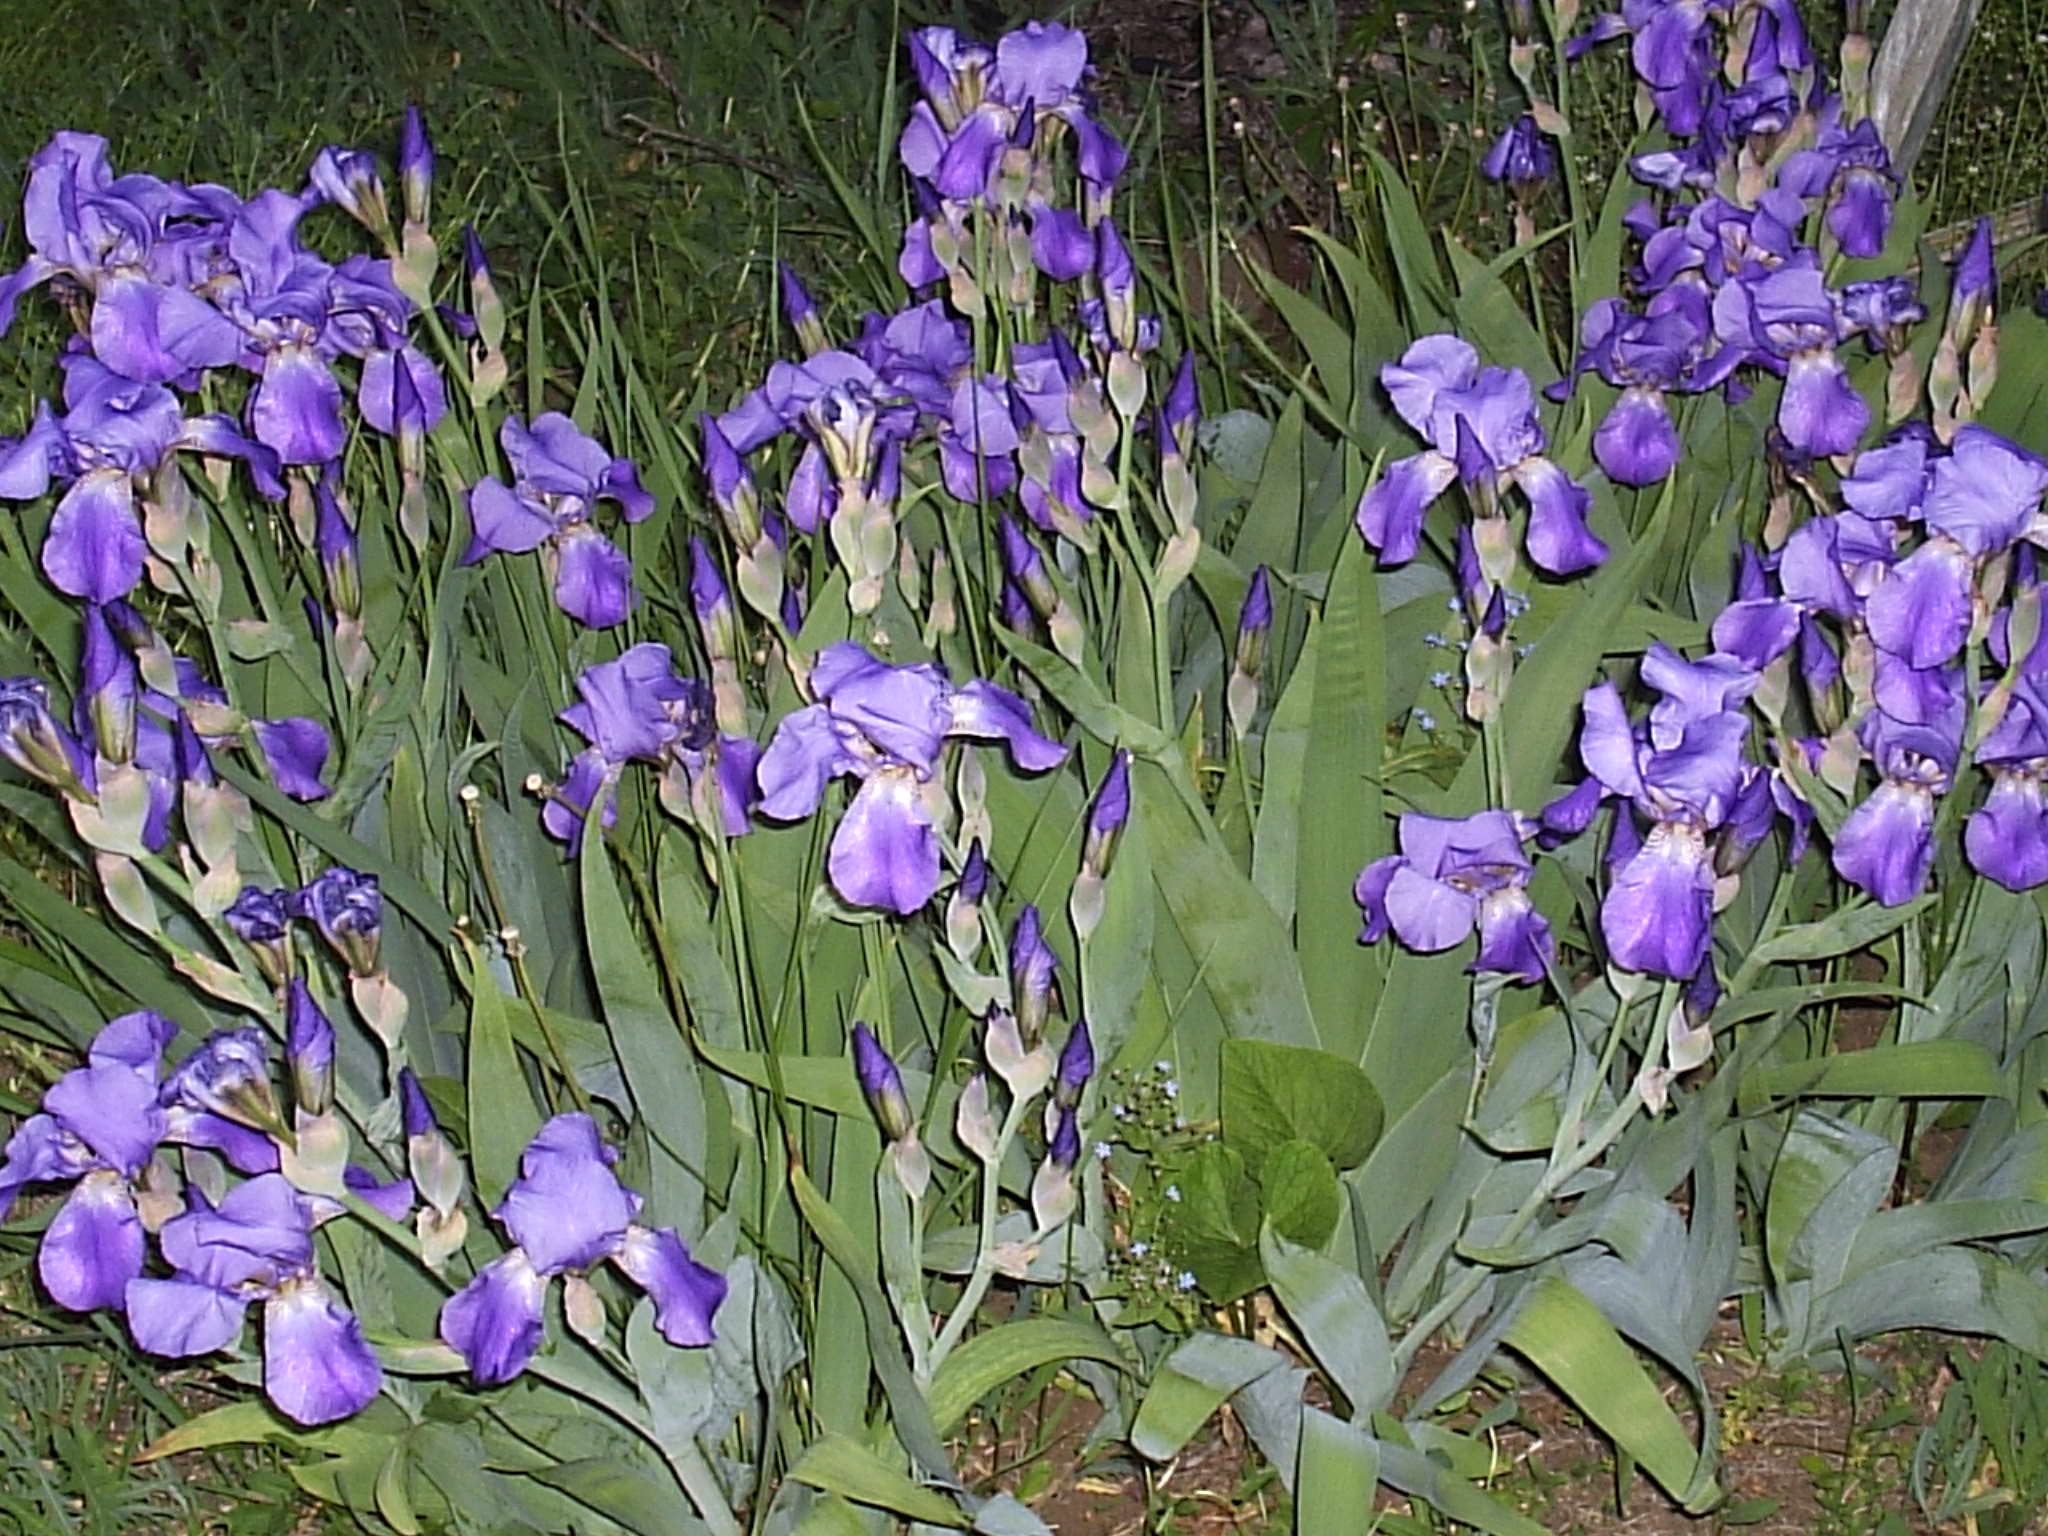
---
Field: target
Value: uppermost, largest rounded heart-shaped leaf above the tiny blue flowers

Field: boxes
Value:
[1223,1040,1386,1174]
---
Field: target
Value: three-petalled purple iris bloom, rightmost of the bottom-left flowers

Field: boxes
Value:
[440,1114,725,1386]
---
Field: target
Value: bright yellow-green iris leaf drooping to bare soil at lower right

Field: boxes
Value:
[1505,1274,1720,1511]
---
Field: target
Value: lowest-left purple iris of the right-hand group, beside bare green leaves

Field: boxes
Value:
[1354,811,1552,983]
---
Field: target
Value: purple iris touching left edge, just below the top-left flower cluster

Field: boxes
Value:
[0,350,285,602]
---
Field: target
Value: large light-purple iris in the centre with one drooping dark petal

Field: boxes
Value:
[758,641,1067,913]
